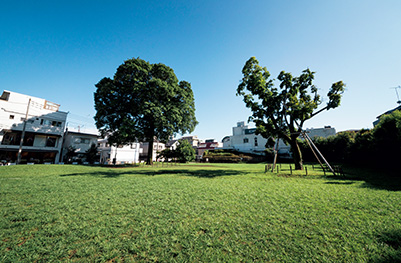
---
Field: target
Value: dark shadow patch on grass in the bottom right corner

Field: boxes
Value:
[372,229,401,263]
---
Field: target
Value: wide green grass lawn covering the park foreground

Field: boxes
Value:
[0,164,401,262]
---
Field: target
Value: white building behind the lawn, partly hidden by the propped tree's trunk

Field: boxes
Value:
[222,121,290,155]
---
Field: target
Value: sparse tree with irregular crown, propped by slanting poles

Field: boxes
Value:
[237,57,345,169]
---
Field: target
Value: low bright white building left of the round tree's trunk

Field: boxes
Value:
[98,139,142,164]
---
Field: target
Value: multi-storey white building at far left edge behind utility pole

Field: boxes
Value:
[0,90,67,163]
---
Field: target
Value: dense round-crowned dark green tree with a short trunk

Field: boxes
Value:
[95,58,198,164]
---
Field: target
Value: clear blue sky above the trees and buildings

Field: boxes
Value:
[0,0,401,140]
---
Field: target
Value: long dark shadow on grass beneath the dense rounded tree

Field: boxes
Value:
[60,169,243,178]
